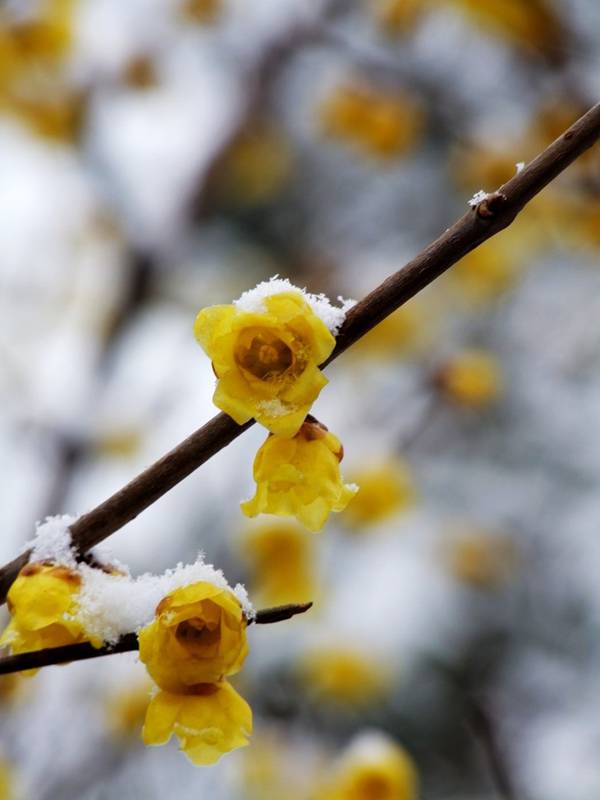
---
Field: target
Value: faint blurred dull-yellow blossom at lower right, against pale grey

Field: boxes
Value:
[445,530,516,589]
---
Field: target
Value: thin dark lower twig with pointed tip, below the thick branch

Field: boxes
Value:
[0,603,312,675]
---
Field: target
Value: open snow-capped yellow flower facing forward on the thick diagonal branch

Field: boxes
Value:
[194,292,335,436]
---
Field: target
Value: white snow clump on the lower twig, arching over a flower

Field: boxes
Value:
[78,555,255,644]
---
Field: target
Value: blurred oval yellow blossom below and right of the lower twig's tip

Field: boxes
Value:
[299,646,389,706]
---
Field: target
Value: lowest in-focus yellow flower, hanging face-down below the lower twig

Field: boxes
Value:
[142,681,252,765]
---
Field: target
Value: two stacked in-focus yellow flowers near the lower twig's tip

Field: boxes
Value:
[139,581,252,764]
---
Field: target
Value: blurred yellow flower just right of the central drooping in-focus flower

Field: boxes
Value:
[344,458,415,528]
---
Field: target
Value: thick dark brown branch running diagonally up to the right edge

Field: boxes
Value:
[0,103,600,602]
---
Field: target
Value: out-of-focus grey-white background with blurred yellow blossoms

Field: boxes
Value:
[0,0,600,800]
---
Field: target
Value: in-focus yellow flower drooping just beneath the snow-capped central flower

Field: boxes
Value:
[241,421,357,532]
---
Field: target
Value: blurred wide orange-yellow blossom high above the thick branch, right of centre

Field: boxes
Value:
[319,84,421,158]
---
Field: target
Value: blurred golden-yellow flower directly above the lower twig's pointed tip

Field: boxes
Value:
[243,522,316,606]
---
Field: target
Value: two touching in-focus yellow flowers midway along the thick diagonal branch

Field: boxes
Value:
[195,286,357,531]
